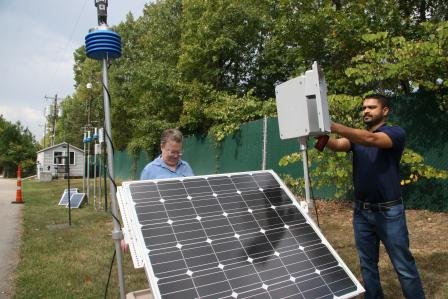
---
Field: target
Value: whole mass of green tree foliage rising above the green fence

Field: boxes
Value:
[46,0,448,196]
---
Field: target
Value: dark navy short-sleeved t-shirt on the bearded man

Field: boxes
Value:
[351,124,406,203]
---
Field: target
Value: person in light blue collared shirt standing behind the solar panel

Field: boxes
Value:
[140,129,194,180]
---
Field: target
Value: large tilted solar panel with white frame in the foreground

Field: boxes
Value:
[117,171,364,298]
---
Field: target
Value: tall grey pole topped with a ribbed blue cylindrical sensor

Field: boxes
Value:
[85,0,125,299]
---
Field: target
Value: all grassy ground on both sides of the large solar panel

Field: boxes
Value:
[14,180,448,299]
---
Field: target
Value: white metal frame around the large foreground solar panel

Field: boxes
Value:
[117,170,364,299]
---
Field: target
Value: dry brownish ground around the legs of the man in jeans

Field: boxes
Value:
[310,201,448,299]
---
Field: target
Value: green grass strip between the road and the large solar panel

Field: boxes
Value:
[14,180,148,298]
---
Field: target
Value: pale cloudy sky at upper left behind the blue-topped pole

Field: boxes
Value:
[0,0,149,141]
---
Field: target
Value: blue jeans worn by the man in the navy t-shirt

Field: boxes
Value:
[353,204,425,299]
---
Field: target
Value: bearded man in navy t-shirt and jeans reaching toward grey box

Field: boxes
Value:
[327,94,425,298]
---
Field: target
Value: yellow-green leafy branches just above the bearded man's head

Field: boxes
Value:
[346,22,448,111]
